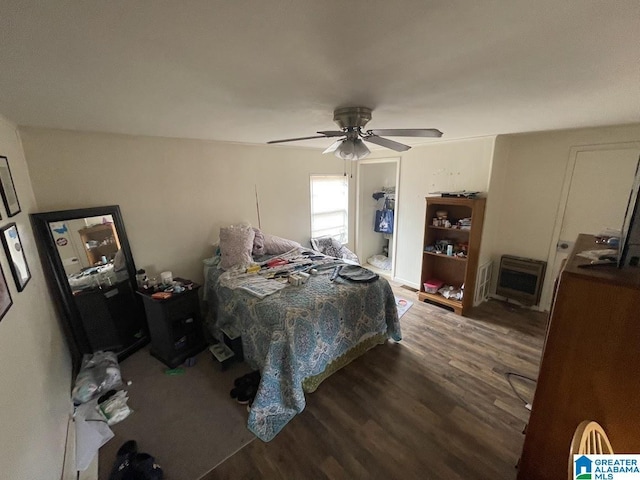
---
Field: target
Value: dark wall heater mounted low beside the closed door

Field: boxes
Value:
[496,255,547,306]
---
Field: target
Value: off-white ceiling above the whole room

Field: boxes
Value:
[0,0,640,148]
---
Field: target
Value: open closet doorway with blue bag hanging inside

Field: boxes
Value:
[356,158,400,279]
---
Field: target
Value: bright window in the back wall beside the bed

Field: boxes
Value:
[311,175,349,243]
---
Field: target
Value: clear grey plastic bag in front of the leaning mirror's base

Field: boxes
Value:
[72,352,122,405]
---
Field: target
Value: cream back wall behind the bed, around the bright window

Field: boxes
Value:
[21,128,355,281]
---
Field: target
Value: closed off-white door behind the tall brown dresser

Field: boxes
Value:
[541,145,640,310]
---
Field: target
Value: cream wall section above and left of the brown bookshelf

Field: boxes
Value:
[395,137,494,288]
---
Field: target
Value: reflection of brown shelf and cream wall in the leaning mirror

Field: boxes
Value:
[49,215,129,295]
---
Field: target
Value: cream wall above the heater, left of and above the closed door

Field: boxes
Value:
[491,124,640,310]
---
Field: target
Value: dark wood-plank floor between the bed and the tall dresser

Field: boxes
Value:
[202,285,547,480]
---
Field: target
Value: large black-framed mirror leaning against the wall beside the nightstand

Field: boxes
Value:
[30,205,149,370]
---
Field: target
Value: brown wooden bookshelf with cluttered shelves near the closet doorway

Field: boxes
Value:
[418,197,486,315]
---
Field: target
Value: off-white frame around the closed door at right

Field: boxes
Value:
[540,142,640,307]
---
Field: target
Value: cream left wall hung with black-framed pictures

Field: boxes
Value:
[0,117,71,480]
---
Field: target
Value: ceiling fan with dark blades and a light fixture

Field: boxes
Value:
[267,107,442,160]
